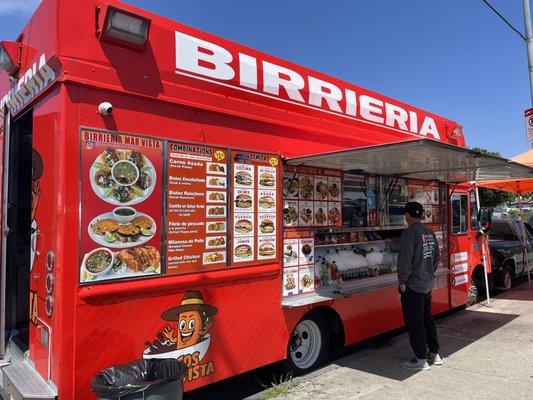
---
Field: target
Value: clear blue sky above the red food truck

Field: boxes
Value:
[0,0,531,157]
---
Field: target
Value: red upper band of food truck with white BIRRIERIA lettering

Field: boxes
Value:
[0,0,465,146]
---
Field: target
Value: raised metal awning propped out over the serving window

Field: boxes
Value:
[285,139,533,183]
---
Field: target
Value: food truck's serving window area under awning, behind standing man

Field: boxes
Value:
[282,166,446,304]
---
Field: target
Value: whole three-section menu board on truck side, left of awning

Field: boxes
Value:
[79,129,281,284]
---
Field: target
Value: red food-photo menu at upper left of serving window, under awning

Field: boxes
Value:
[283,166,342,228]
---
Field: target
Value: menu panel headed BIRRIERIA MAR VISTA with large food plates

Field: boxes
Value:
[79,130,163,283]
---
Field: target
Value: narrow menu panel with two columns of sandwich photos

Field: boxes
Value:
[231,151,280,266]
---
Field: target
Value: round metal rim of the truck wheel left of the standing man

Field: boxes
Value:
[289,320,322,369]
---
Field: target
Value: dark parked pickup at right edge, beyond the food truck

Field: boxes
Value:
[488,219,533,290]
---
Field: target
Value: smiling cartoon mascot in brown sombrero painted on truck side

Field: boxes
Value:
[161,291,218,350]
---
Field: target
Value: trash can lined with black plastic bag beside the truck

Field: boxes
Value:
[92,359,187,400]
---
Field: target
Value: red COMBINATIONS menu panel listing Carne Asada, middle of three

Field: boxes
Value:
[166,142,228,274]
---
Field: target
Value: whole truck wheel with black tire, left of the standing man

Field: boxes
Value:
[287,314,330,375]
